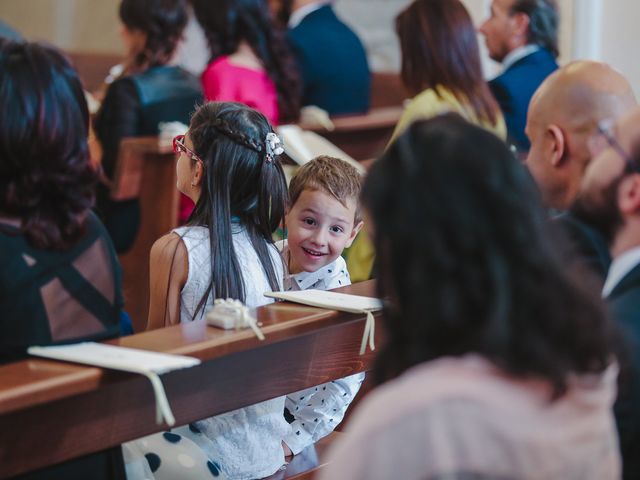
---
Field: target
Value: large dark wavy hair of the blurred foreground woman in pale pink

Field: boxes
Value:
[363,114,612,393]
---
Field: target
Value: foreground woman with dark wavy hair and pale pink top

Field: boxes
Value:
[322,114,620,480]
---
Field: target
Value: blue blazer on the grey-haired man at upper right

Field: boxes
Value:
[489,48,558,151]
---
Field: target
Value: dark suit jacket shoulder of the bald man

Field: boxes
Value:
[553,213,611,285]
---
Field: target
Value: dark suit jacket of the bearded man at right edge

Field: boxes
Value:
[608,265,640,480]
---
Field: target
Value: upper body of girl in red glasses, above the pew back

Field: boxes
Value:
[147,102,287,329]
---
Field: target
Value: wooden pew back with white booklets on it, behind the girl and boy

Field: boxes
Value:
[0,281,382,478]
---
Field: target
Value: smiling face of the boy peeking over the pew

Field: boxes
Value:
[286,190,362,273]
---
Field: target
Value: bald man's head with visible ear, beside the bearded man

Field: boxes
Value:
[526,61,637,210]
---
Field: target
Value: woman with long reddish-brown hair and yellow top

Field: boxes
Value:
[393,0,506,139]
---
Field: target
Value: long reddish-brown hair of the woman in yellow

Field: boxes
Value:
[396,0,499,124]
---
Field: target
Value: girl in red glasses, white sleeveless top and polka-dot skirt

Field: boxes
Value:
[124,103,291,480]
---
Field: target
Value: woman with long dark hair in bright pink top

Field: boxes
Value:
[192,0,301,125]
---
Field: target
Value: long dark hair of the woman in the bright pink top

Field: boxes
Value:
[192,0,301,121]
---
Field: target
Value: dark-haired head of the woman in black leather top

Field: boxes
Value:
[120,0,188,71]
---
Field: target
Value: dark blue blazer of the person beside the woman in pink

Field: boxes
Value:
[287,5,371,115]
